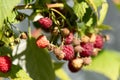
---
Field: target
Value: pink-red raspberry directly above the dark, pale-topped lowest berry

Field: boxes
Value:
[62,45,74,60]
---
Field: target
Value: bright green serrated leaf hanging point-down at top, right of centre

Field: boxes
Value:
[73,1,89,20]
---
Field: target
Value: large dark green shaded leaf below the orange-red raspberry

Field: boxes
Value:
[21,38,55,80]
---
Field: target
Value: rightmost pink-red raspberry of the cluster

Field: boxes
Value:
[94,35,104,49]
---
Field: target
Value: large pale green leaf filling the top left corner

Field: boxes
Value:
[0,0,20,29]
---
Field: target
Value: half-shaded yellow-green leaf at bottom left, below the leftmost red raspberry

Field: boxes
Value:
[0,65,32,80]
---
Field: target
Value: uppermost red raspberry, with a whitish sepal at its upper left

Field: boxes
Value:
[39,17,52,28]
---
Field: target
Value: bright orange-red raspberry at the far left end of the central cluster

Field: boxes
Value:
[36,35,49,48]
